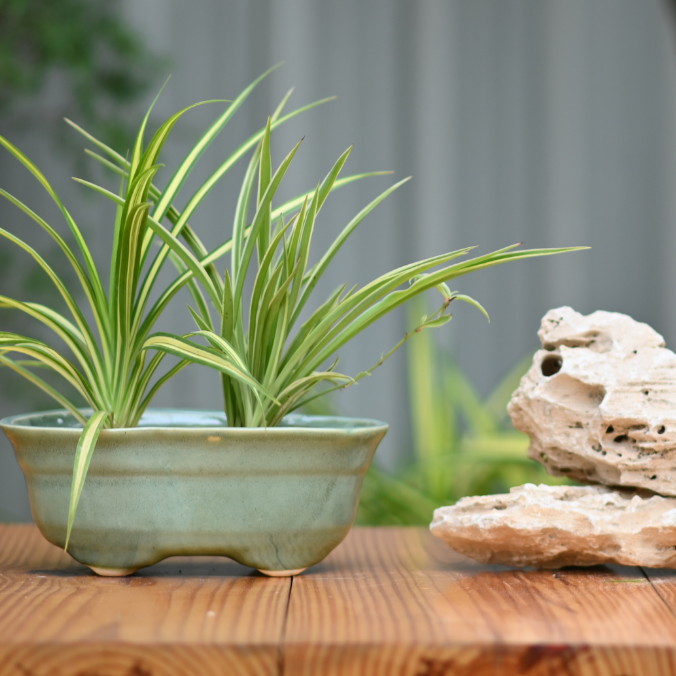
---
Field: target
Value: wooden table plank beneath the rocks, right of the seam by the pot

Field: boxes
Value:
[284,528,676,676]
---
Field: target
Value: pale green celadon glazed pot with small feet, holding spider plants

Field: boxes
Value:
[0,409,387,575]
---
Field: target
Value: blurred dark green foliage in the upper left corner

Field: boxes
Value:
[0,0,163,150]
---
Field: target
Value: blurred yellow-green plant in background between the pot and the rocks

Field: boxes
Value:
[334,302,570,525]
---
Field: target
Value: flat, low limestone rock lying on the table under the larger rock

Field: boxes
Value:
[430,484,676,568]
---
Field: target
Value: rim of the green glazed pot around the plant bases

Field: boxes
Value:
[0,408,389,436]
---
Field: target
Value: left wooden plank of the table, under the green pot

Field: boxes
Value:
[0,525,290,676]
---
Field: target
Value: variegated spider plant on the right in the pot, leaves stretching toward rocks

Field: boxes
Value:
[129,120,588,427]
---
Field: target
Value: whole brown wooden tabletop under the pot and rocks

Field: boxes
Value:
[0,525,676,676]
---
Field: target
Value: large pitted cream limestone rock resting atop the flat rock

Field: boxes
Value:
[508,307,676,496]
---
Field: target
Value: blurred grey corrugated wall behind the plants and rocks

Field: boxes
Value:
[0,0,676,519]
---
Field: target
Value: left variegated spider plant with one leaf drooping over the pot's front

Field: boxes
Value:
[0,69,374,547]
